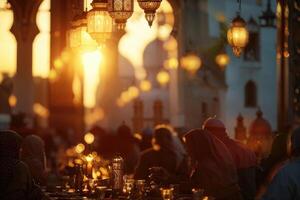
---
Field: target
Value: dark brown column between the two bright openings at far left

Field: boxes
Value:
[9,0,42,119]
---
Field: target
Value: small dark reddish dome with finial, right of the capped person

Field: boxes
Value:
[249,109,272,138]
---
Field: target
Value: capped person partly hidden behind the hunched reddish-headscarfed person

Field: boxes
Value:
[202,118,256,200]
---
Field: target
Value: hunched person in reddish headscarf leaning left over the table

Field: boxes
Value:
[184,129,242,200]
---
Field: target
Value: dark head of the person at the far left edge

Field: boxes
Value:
[0,131,22,159]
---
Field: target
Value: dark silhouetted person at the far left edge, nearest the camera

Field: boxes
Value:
[0,131,43,200]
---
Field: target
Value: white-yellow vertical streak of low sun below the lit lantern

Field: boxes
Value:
[82,50,103,108]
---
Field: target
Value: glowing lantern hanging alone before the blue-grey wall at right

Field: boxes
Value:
[227,15,249,57]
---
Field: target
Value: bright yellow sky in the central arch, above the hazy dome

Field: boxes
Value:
[119,0,174,80]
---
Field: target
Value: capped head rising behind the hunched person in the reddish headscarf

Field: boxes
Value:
[202,118,227,139]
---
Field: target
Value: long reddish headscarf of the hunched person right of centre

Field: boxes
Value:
[184,129,237,185]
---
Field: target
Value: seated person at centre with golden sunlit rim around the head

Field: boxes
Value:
[135,125,188,183]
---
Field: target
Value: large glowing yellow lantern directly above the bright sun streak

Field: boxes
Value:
[87,0,113,45]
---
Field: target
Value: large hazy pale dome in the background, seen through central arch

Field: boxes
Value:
[143,39,168,70]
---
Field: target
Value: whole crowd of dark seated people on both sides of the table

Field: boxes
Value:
[0,118,300,200]
